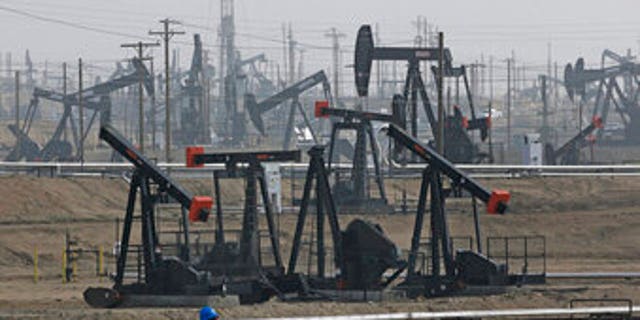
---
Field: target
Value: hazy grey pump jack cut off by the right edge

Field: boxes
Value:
[564,50,640,143]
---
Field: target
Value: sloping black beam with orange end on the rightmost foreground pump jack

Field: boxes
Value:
[387,124,511,214]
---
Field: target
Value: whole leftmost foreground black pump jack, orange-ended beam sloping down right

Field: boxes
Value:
[84,125,212,308]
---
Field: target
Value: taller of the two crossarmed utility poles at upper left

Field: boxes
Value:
[149,18,184,163]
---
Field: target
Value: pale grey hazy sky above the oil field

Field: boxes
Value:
[0,0,640,91]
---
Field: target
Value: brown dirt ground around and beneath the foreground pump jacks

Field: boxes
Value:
[0,176,640,319]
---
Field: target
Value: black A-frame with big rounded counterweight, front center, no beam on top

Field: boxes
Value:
[287,146,406,299]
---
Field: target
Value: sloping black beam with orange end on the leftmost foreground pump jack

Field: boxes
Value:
[100,125,213,222]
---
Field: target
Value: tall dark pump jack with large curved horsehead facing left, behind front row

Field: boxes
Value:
[355,25,490,163]
